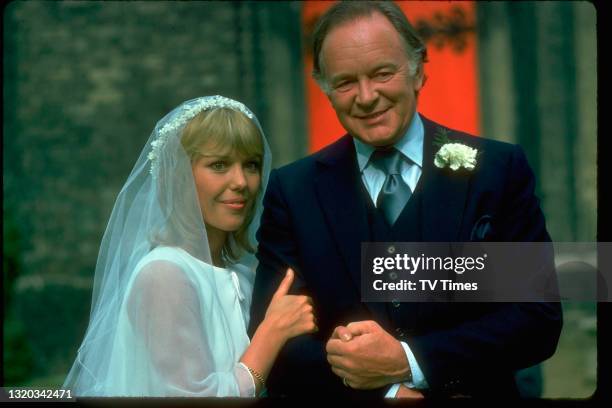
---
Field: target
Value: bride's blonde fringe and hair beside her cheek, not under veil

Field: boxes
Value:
[181,108,264,262]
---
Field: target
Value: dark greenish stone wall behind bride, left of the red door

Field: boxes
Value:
[3,1,307,384]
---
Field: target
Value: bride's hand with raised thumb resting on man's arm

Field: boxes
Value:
[264,268,319,341]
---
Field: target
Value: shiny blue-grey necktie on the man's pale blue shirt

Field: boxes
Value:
[372,148,412,226]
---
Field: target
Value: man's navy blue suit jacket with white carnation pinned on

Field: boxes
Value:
[249,117,562,398]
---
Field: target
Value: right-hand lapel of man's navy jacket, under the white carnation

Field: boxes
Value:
[419,115,470,242]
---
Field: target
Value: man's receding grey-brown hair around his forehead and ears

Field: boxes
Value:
[312,1,427,94]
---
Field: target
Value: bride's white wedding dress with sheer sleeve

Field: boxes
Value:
[100,247,255,397]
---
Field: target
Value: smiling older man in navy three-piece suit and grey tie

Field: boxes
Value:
[250,2,561,397]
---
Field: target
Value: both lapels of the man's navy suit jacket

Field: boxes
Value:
[316,115,470,327]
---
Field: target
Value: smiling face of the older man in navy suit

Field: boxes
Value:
[320,13,423,146]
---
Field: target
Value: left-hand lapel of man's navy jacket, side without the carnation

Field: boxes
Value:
[316,135,387,319]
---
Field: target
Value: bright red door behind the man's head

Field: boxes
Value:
[302,1,479,152]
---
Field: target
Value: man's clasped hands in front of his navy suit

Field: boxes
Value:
[325,320,410,389]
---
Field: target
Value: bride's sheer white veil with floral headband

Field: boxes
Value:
[63,95,271,395]
